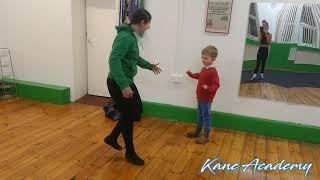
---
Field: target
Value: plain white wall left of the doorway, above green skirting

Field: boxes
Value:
[0,0,86,100]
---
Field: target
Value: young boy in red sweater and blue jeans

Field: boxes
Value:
[187,46,220,144]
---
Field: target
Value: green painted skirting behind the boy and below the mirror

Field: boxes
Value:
[143,102,320,144]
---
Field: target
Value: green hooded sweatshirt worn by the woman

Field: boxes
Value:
[108,24,153,90]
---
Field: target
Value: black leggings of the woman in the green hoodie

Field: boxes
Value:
[107,78,142,153]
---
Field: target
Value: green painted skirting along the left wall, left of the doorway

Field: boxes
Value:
[6,79,70,104]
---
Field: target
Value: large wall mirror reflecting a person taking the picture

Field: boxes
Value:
[240,3,320,105]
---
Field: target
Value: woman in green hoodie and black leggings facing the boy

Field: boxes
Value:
[104,9,161,165]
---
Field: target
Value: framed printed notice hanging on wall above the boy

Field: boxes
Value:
[206,0,233,34]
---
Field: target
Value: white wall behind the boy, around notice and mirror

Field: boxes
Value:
[136,0,320,126]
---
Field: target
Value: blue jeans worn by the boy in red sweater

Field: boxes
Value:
[197,101,211,133]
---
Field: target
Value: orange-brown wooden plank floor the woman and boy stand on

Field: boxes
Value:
[0,100,320,179]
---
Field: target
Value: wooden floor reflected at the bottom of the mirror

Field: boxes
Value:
[239,83,320,106]
